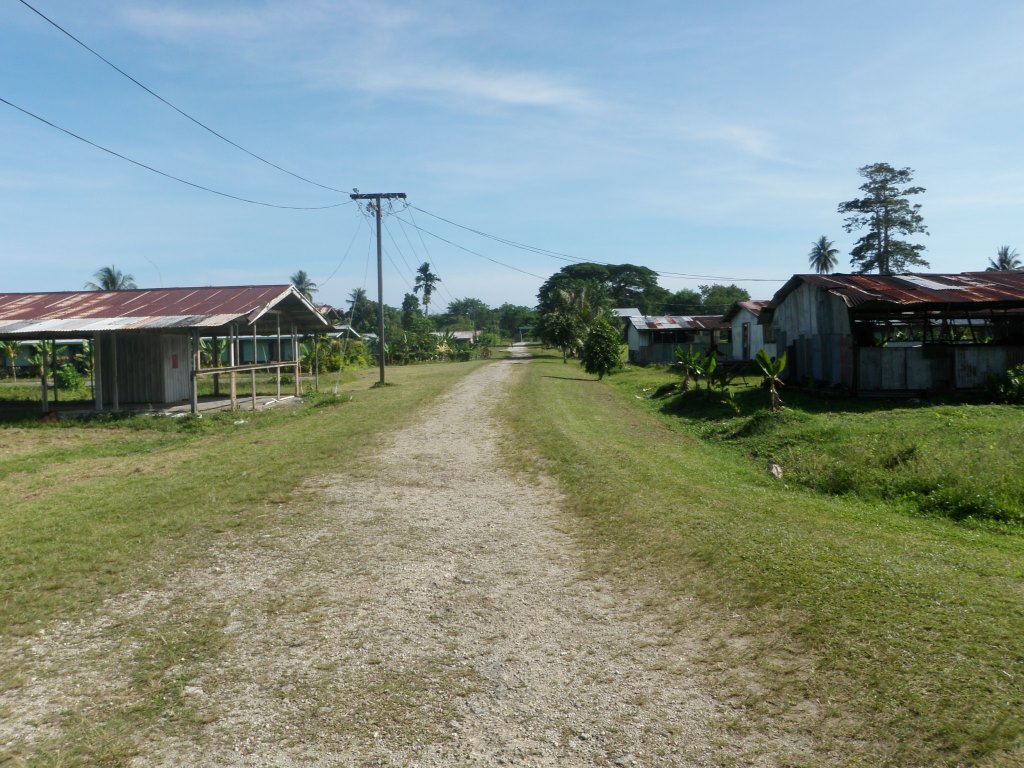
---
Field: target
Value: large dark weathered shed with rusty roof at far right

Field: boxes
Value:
[759,271,1024,393]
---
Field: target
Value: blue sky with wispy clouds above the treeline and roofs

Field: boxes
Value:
[0,0,1024,309]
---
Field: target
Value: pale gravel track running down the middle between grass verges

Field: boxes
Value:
[0,352,741,766]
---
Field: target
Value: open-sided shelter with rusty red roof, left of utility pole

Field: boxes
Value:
[0,285,329,411]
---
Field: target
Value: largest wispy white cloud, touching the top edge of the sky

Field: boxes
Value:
[118,0,599,112]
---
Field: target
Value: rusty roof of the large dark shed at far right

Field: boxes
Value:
[771,270,1024,307]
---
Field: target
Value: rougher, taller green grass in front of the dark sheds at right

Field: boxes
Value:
[611,368,1024,530]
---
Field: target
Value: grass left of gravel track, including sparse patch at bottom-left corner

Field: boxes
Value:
[0,362,479,765]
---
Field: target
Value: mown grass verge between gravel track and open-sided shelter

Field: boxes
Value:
[0,362,489,635]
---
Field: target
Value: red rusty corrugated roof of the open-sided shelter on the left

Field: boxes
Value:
[0,285,328,337]
